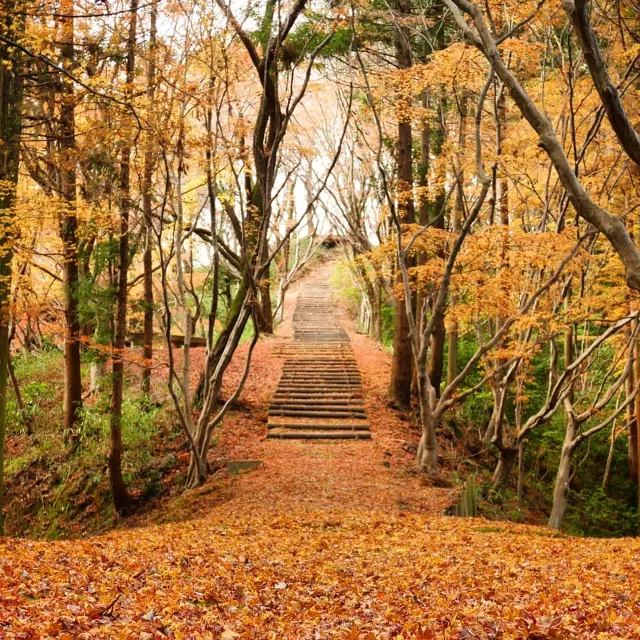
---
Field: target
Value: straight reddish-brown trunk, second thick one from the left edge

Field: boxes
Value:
[59,0,82,448]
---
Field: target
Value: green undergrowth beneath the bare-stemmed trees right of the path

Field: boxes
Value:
[330,261,640,537]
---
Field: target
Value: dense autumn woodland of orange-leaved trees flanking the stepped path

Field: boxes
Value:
[0,0,640,544]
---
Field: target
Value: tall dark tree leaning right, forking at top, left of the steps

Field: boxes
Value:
[179,0,332,487]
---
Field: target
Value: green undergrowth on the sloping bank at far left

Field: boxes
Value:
[5,351,182,539]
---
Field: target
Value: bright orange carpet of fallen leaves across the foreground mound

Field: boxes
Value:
[0,505,640,640]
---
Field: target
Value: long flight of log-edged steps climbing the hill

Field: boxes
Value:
[267,282,371,440]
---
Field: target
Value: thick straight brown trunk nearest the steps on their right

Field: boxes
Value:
[390,0,420,409]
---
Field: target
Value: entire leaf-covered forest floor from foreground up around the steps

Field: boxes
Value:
[0,262,640,640]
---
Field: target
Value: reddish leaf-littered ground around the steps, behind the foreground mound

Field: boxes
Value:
[136,264,454,524]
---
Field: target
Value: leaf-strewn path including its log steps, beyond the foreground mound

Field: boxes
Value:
[200,261,452,514]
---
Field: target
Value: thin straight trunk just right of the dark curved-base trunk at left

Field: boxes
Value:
[142,0,158,396]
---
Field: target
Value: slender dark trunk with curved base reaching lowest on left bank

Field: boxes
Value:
[109,0,138,513]
